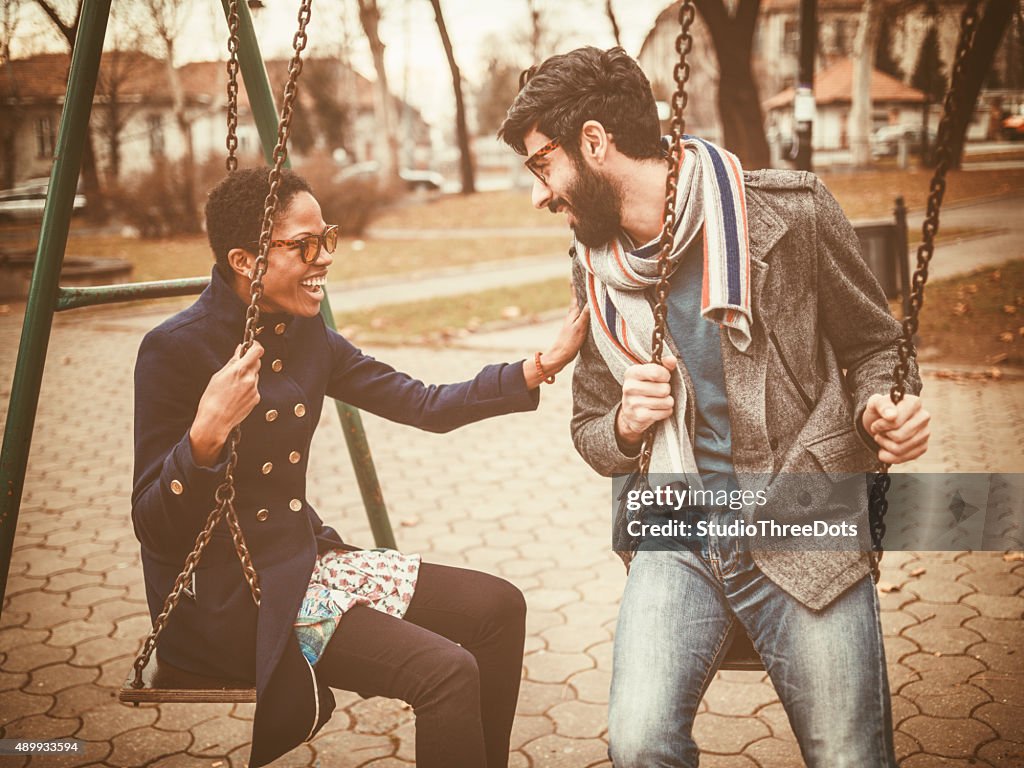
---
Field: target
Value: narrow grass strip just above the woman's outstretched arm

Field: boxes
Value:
[334,278,571,344]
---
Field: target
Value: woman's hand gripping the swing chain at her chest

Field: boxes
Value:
[188,341,263,467]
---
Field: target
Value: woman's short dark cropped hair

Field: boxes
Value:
[206,168,312,274]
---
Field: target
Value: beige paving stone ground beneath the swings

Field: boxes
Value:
[0,305,1024,768]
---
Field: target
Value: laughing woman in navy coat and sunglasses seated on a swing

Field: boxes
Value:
[132,169,587,768]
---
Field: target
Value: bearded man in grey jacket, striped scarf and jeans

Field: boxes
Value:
[499,48,929,768]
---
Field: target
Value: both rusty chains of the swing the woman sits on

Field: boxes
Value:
[131,0,312,688]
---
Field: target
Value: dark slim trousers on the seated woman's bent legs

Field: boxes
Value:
[316,562,526,768]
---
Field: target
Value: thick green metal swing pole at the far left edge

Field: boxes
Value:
[0,0,111,611]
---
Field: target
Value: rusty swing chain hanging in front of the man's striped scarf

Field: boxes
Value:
[637,0,696,478]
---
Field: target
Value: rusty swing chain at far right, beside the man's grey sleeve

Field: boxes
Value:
[869,0,978,584]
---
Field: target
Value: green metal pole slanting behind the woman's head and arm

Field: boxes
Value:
[221,0,398,549]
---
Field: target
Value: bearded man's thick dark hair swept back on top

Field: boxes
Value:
[498,47,662,160]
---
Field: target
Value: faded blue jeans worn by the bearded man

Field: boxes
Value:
[608,519,896,768]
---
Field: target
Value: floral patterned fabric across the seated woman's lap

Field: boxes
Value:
[295,549,420,665]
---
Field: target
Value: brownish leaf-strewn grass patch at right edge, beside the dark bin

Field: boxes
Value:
[893,260,1024,366]
